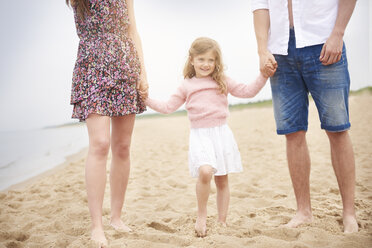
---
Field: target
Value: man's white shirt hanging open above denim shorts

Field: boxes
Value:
[251,0,338,55]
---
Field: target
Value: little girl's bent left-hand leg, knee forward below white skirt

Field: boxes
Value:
[195,165,213,237]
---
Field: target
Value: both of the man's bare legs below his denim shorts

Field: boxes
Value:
[285,131,358,233]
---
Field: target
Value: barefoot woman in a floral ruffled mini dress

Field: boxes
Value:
[66,0,148,247]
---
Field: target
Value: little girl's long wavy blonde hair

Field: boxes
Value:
[183,37,227,94]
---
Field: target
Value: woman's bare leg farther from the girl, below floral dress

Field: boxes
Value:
[85,114,110,244]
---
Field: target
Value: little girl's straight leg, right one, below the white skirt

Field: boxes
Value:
[214,175,230,226]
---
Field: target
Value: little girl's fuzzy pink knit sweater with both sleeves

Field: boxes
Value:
[145,74,267,128]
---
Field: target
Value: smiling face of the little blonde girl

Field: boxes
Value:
[191,50,216,78]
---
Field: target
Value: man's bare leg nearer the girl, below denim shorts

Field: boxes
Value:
[284,131,312,227]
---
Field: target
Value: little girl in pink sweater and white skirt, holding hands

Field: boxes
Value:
[145,38,267,237]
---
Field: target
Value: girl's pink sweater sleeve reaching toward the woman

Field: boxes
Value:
[145,85,186,114]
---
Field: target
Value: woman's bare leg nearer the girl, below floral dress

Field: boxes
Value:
[110,114,135,232]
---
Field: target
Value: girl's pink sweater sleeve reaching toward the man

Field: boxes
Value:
[227,73,267,98]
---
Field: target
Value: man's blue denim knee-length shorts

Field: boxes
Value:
[270,29,350,134]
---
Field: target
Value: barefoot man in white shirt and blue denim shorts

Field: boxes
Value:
[251,0,358,233]
